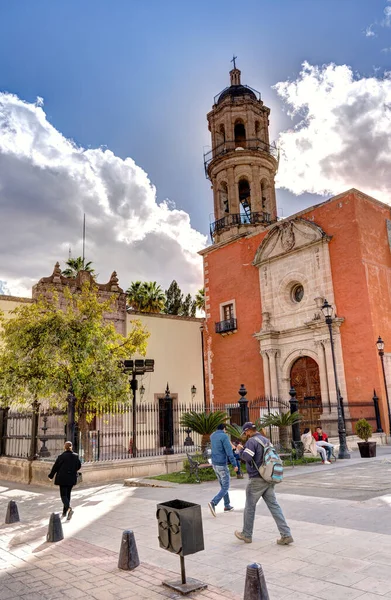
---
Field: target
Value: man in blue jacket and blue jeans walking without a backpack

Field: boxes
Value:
[208,423,238,517]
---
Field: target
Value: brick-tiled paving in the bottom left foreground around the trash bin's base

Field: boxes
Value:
[0,529,234,600]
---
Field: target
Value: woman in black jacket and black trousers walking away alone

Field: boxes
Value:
[48,442,81,521]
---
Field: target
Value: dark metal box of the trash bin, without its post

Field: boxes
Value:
[156,500,204,556]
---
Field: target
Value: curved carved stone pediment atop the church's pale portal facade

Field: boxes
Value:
[253,218,331,267]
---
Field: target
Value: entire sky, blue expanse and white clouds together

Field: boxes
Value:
[0,0,391,296]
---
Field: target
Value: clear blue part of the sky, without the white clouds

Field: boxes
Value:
[0,0,391,296]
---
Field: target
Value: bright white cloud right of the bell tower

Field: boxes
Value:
[275,63,391,202]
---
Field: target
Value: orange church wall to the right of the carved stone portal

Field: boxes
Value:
[304,192,391,426]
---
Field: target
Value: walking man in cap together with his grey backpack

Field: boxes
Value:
[235,423,293,546]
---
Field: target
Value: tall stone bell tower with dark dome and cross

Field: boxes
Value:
[204,62,278,243]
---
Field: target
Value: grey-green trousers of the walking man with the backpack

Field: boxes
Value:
[243,477,291,538]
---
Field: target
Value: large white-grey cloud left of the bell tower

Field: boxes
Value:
[0,93,206,295]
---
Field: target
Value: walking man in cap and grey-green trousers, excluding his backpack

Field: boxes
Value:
[235,423,293,546]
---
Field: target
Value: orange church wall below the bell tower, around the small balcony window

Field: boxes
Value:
[204,232,265,404]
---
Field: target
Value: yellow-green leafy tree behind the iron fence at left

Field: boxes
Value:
[0,284,149,460]
